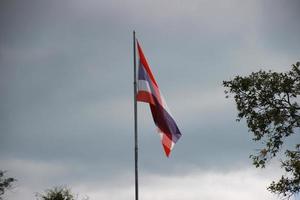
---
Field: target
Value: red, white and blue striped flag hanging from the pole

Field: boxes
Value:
[137,42,181,156]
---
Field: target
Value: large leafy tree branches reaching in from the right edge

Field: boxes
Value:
[223,62,300,199]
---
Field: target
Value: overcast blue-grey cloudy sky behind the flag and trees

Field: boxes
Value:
[0,0,300,200]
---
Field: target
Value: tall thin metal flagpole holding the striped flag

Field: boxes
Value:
[133,31,139,200]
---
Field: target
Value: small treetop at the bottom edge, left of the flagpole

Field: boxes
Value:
[36,186,88,200]
